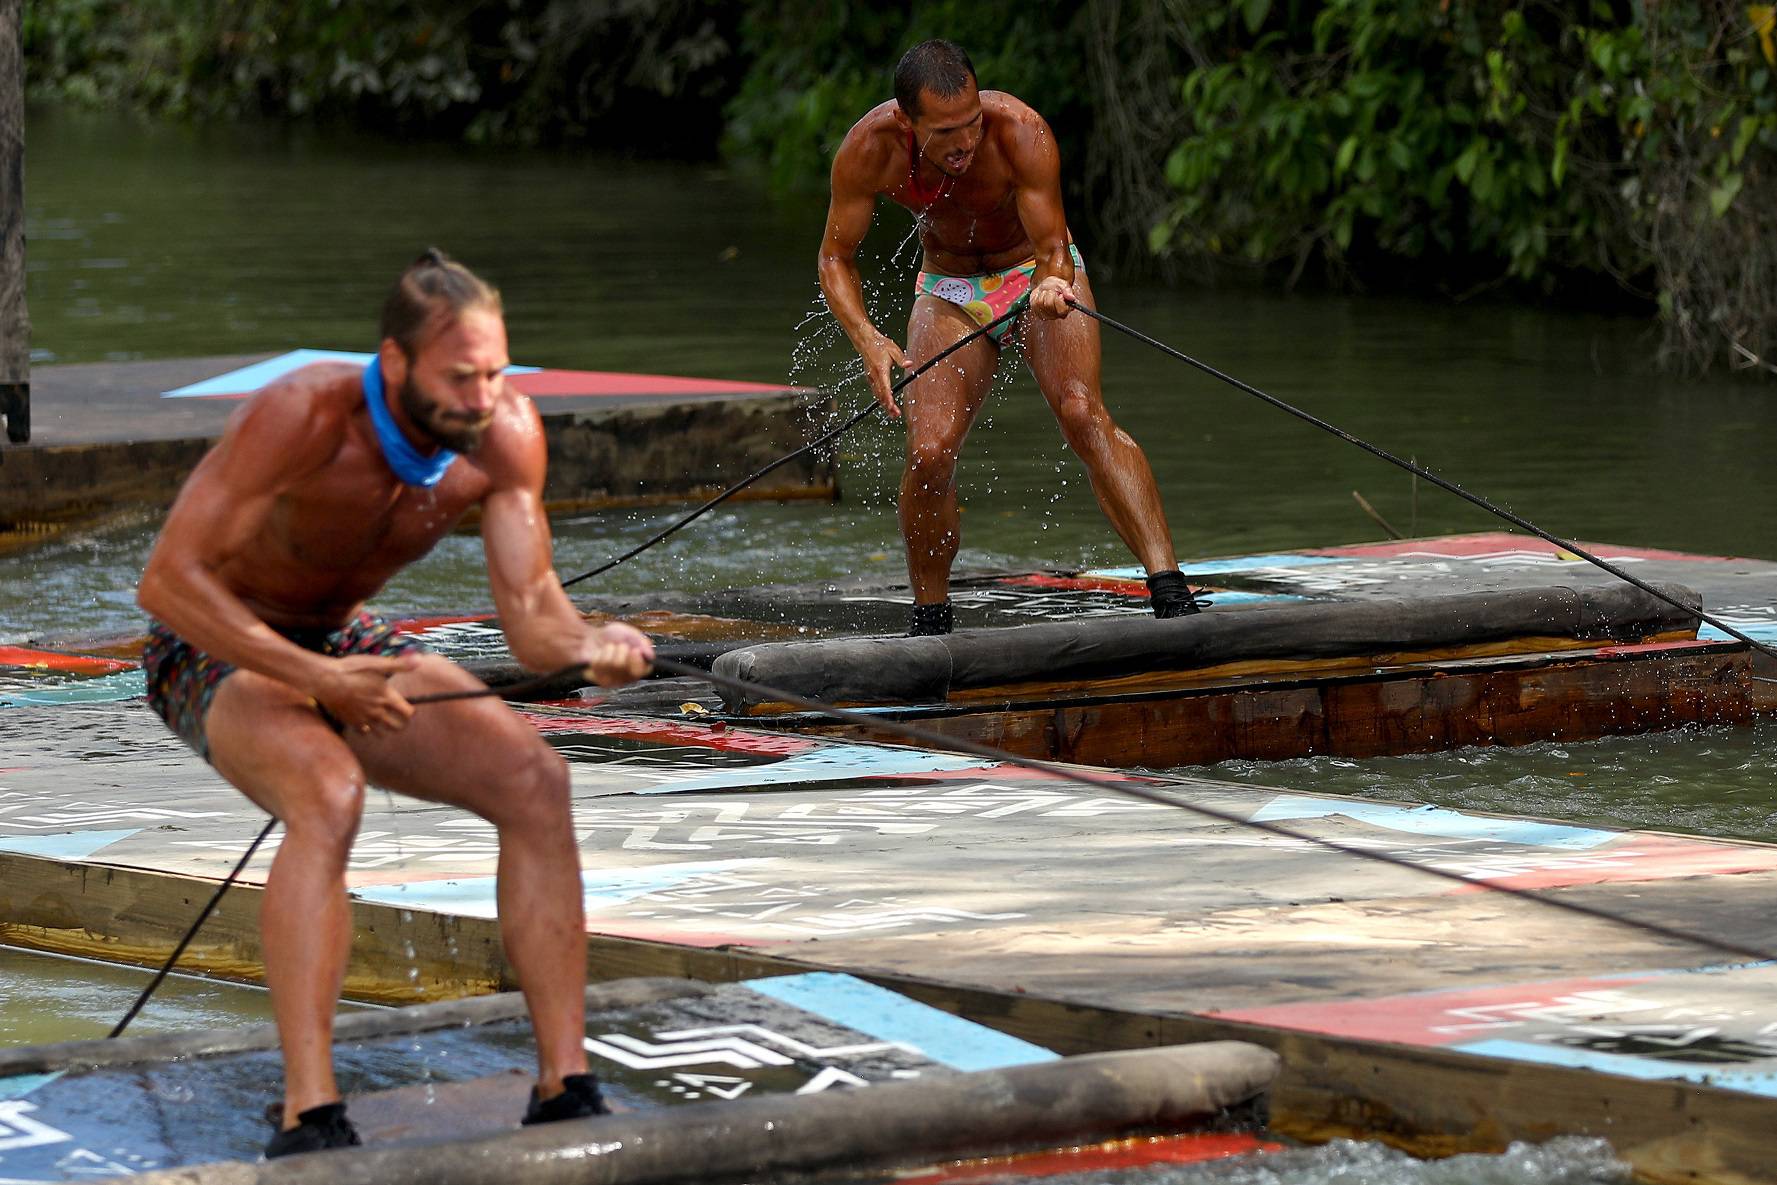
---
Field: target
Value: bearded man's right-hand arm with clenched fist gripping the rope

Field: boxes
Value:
[482,396,654,684]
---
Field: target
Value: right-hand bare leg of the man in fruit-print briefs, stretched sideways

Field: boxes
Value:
[1020,272,1178,574]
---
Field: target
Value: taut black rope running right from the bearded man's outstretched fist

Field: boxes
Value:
[654,657,1777,963]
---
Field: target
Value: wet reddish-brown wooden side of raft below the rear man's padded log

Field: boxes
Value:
[785,643,1773,769]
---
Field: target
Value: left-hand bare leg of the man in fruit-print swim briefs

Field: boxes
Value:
[901,297,999,604]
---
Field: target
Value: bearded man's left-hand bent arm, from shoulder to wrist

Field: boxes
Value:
[137,378,360,696]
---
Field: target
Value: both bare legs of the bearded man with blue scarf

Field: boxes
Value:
[204,656,586,1128]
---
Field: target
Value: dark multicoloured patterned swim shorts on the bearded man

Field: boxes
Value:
[142,613,425,760]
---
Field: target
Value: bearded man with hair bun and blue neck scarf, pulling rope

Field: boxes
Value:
[137,249,654,1158]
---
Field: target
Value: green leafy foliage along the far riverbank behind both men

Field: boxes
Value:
[23,0,1777,373]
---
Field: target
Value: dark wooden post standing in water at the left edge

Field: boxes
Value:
[0,0,30,444]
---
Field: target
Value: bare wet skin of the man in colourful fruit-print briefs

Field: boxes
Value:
[819,85,1178,604]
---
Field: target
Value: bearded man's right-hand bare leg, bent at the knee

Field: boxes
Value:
[350,654,586,1098]
